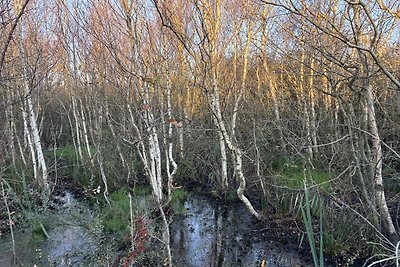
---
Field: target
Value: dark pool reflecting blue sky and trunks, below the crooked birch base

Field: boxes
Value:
[171,196,312,267]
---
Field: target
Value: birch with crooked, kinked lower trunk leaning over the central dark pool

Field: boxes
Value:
[153,0,261,218]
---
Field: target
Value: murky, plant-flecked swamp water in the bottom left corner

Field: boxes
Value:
[0,192,100,267]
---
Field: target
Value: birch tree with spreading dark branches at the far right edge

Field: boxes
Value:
[262,0,400,243]
